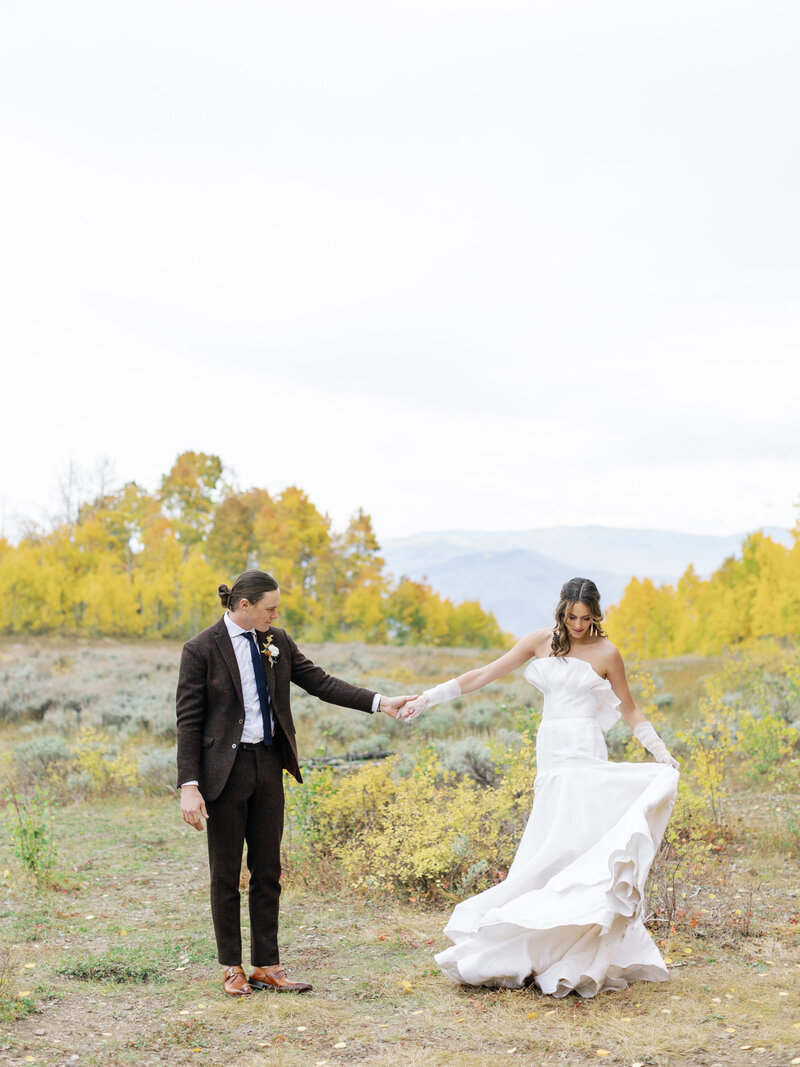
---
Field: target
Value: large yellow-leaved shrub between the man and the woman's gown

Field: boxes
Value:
[288,738,535,898]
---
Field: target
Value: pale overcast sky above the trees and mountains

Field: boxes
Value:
[0,0,800,538]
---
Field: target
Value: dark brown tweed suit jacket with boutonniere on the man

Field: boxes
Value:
[176,619,374,800]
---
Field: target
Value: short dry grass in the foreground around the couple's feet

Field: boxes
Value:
[0,799,800,1067]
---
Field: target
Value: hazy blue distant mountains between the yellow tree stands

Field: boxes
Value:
[381,526,791,636]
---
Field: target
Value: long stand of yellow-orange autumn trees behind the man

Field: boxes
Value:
[0,452,508,648]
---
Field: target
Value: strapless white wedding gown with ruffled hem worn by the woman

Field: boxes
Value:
[436,656,678,997]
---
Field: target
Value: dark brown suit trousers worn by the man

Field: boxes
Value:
[206,737,284,967]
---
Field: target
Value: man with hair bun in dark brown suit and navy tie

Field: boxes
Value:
[176,571,412,997]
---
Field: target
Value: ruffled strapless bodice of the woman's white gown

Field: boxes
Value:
[523,656,620,730]
